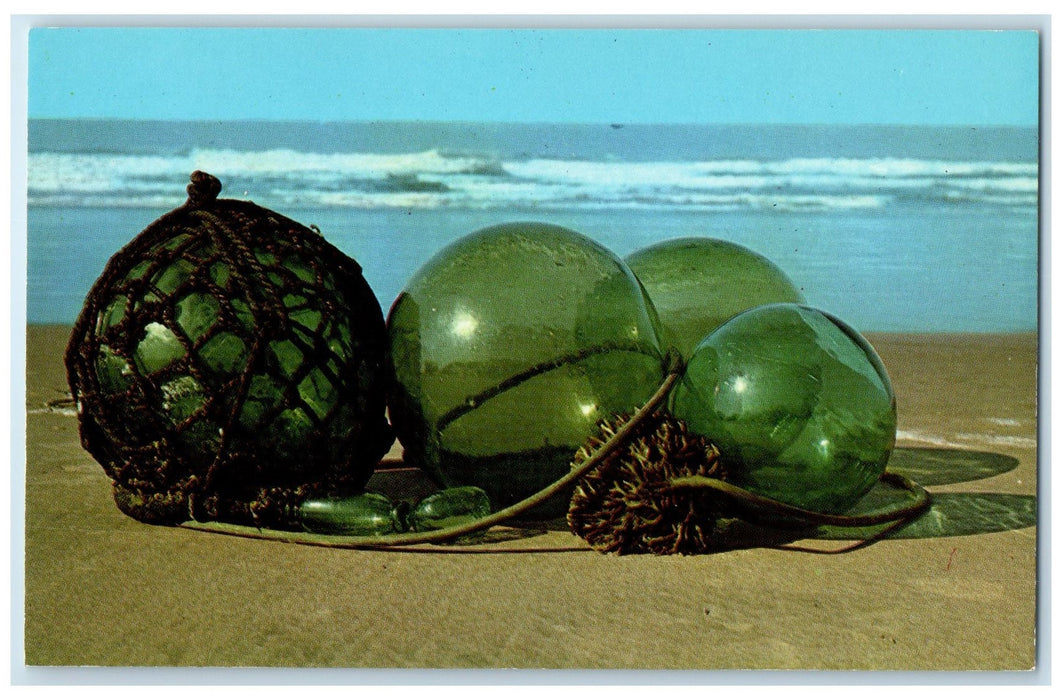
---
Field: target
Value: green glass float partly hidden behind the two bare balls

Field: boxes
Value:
[627,237,805,360]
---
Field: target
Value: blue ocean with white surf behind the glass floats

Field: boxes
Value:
[27,120,1040,332]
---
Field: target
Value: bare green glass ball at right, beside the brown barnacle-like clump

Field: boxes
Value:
[670,304,896,514]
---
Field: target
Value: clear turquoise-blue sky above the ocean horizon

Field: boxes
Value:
[28,28,1040,125]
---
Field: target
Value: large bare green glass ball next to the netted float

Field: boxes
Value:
[388,223,665,516]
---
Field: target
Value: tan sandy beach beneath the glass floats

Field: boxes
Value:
[24,326,1038,670]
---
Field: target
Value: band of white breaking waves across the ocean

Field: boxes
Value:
[28,149,1039,211]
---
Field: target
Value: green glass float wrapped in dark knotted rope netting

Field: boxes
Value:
[66,172,393,525]
